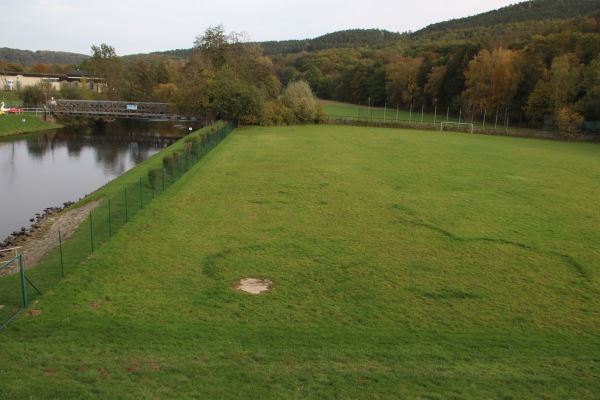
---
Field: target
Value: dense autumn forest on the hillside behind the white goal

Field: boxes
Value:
[274,13,600,128]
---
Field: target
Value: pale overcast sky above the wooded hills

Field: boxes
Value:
[7,0,520,56]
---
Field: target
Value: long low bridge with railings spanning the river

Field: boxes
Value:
[49,99,197,119]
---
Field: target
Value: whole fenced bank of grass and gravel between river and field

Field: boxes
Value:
[0,123,234,329]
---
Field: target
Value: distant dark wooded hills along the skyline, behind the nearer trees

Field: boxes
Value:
[0,0,600,67]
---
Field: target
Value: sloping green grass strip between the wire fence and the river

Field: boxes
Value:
[0,122,233,332]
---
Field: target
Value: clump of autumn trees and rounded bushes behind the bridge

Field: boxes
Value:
[21,25,324,125]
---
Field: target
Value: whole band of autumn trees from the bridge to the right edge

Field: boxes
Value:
[4,0,600,132]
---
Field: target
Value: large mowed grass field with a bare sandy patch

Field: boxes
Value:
[0,126,600,399]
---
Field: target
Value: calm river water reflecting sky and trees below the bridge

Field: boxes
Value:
[0,119,200,242]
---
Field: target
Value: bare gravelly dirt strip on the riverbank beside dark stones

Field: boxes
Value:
[0,199,103,275]
